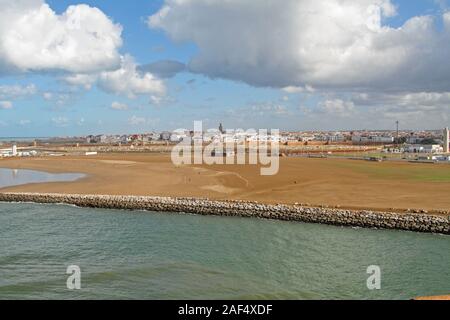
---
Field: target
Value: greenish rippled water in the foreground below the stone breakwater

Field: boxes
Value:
[0,203,450,299]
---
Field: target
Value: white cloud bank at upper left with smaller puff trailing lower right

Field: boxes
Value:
[0,0,165,98]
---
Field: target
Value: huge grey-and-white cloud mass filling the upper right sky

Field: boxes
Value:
[148,0,450,91]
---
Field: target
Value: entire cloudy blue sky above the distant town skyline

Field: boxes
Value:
[0,0,450,137]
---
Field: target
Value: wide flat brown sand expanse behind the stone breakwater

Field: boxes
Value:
[0,154,450,211]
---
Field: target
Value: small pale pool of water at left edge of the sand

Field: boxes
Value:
[0,168,85,188]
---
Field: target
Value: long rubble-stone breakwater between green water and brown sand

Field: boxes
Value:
[0,193,450,234]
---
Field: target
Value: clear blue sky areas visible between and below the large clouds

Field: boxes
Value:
[0,0,450,136]
